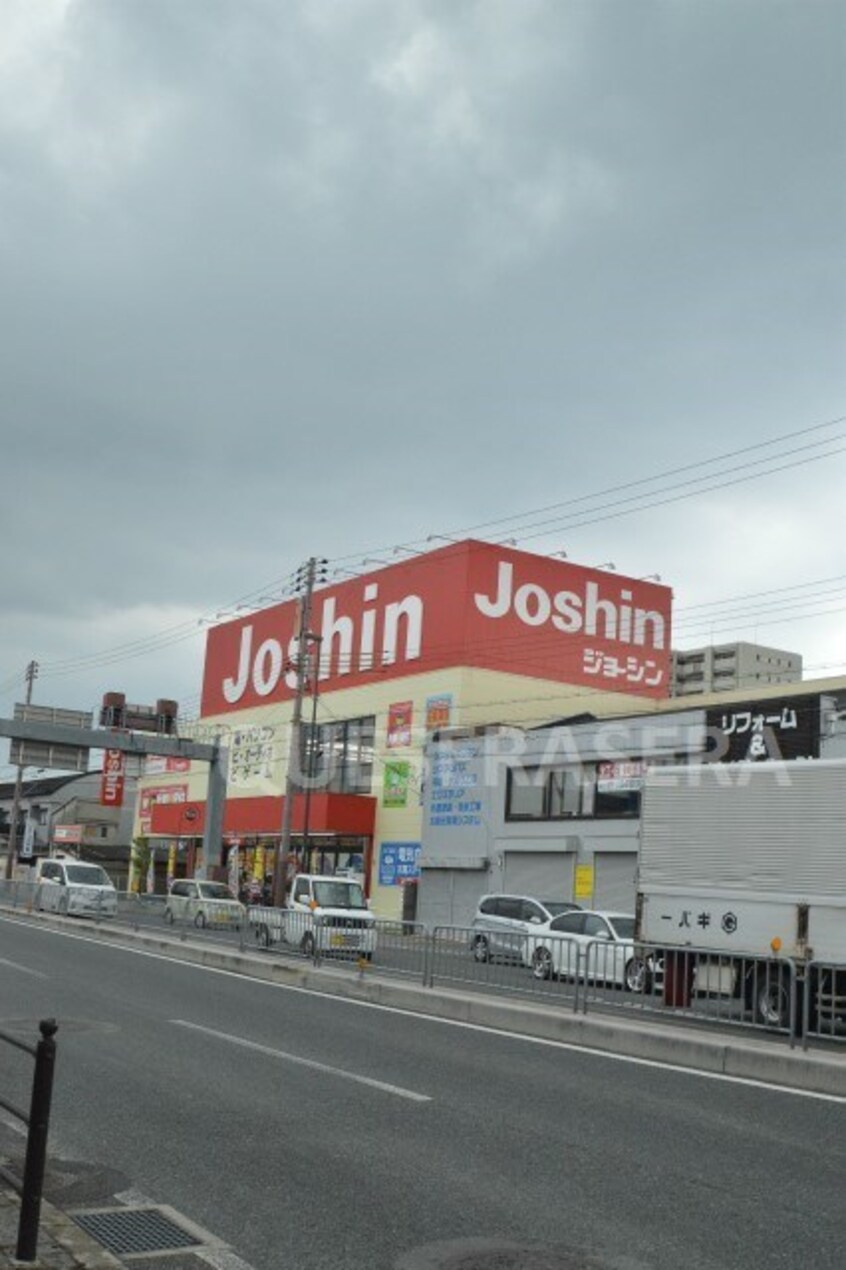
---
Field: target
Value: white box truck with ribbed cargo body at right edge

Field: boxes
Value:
[636,759,846,1031]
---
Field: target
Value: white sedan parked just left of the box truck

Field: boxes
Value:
[530,911,661,992]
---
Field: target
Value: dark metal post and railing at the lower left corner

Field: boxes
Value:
[0,1019,58,1261]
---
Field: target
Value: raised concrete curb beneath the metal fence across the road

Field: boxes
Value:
[6,906,846,1099]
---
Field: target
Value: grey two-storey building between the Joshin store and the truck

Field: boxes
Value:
[418,678,846,926]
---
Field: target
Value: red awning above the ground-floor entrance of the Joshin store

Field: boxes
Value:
[150,794,376,838]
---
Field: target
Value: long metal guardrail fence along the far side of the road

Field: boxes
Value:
[0,880,846,1048]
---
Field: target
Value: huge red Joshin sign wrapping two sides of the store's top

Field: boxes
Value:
[202,540,672,715]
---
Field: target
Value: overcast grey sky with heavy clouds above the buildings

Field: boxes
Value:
[0,0,846,762]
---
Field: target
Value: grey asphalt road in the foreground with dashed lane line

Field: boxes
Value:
[0,918,846,1270]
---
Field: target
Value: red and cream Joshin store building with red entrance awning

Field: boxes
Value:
[135,540,671,916]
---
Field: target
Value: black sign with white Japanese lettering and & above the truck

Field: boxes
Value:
[705,693,821,763]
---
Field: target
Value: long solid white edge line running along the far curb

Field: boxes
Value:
[0,914,846,1105]
